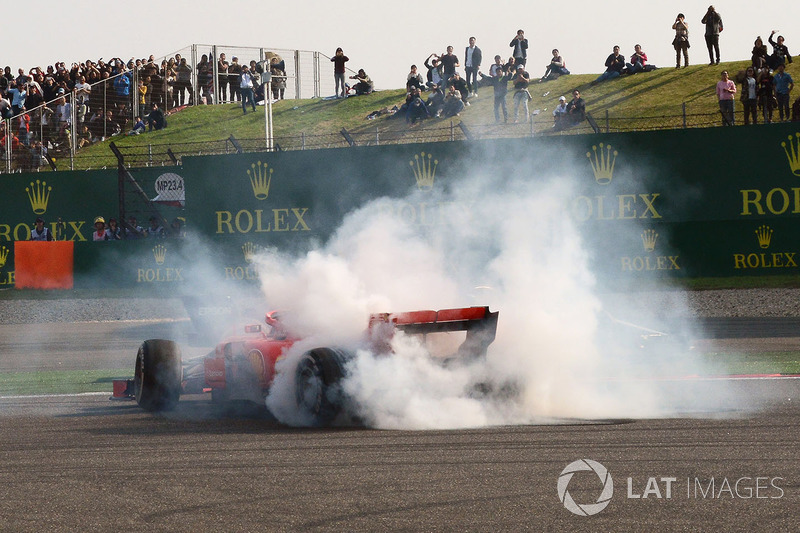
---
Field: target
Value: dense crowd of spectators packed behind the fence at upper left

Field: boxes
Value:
[0,54,286,168]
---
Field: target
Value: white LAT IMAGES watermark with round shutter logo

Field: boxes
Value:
[558,459,786,516]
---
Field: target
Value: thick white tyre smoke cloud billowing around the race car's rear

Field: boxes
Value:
[260,164,728,429]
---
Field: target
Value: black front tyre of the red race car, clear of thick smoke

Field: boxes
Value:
[134,339,182,411]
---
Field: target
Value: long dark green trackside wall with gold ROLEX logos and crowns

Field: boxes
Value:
[0,124,800,288]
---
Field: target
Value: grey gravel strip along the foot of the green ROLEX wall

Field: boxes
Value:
[0,289,800,324]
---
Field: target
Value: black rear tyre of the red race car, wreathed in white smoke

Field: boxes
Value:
[295,348,346,426]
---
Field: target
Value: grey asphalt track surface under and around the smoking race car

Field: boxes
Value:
[0,322,800,531]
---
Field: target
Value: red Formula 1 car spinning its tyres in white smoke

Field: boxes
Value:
[112,307,498,425]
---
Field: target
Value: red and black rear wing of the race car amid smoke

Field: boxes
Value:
[369,307,499,357]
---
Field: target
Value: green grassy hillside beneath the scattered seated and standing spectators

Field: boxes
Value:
[70,57,800,168]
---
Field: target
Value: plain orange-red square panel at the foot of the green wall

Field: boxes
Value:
[14,241,75,289]
